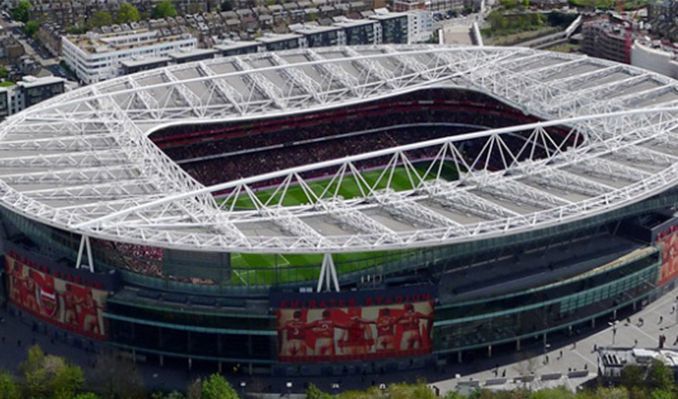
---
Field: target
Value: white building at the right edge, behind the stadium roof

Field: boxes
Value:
[631,40,678,79]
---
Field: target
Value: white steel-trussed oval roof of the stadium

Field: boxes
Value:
[0,45,678,253]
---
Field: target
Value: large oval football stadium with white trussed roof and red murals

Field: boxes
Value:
[0,45,678,376]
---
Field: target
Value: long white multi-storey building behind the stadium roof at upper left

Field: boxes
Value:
[61,30,198,84]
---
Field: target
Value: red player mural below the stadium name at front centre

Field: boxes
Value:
[274,287,433,361]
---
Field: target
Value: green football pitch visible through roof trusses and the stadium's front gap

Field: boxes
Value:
[225,163,458,285]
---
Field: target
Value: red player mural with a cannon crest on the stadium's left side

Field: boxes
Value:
[5,255,106,339]
